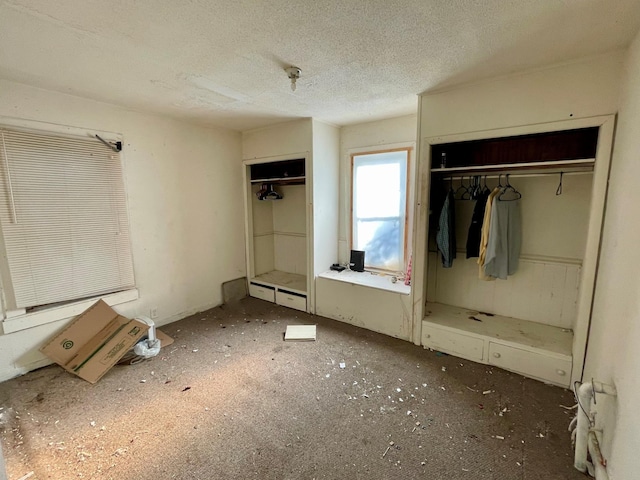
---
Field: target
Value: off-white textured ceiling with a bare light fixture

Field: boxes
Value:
[0,0,640,130]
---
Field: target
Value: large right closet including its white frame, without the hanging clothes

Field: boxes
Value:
[419,117,613,387]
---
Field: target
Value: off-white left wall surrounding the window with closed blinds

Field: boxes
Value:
[0,81,245,380]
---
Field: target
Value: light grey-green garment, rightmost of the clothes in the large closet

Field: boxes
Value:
[484,199,522,280]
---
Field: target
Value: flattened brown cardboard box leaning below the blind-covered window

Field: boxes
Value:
[40,300,149,383]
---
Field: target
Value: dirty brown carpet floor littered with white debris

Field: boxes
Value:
[0,298,584,480]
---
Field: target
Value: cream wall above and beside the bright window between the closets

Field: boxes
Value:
[338,115,417,262]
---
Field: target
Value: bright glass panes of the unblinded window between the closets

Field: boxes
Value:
[351,148,411,271]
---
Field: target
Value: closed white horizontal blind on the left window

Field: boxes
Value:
[0,128,134,308]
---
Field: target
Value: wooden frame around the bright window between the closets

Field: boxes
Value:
[349,145,414,272]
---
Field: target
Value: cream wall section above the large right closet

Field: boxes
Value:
[421,52,624,137]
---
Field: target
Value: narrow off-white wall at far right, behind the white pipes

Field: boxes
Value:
[585,33,640,480]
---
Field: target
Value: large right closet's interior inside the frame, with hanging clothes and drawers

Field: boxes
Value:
[421,122,600,387]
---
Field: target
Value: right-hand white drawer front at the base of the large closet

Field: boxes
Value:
[489,342,571,387]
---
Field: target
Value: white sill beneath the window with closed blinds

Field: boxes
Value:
[2,288,140,335]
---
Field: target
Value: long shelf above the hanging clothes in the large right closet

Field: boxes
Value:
[431,158,596,175]
